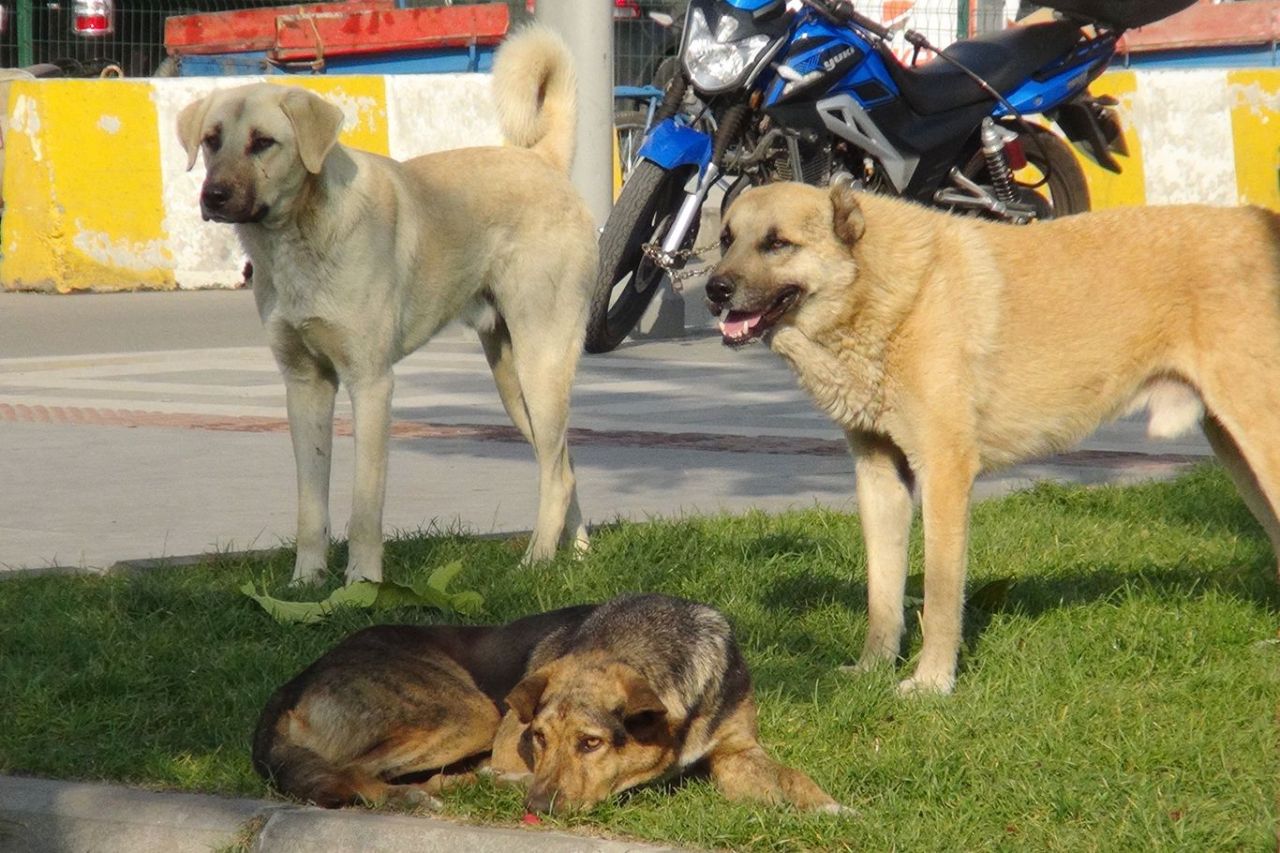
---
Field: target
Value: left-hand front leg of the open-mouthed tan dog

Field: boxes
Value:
[846,432,915,672]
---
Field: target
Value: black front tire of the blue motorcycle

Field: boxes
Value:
[585,160,698,353]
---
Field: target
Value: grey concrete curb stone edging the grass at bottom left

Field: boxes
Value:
[0,776,675,853]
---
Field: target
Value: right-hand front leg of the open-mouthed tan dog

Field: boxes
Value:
[899,455,978,693]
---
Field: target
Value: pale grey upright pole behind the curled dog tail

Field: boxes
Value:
[536,0,613,225]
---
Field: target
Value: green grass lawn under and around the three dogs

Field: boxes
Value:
[0,469,1280,850]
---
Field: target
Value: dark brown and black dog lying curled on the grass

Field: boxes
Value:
[253,594,842,812]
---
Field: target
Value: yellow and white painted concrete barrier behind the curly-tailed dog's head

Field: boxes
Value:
[0,74,502,292]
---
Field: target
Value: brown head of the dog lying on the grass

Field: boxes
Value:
[507,654,676,812]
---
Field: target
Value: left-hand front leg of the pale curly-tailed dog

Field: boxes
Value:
[276,352,338,584]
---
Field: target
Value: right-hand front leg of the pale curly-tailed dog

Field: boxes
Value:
[346,370,396,584]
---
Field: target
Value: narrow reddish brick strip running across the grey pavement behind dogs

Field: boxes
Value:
[0,403,1202,469]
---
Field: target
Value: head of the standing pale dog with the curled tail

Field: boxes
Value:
[178,83,343,223]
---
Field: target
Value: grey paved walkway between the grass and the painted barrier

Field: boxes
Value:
[0,286,1208,570]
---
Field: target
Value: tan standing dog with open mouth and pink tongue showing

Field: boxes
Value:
[707,184,1280,693]
